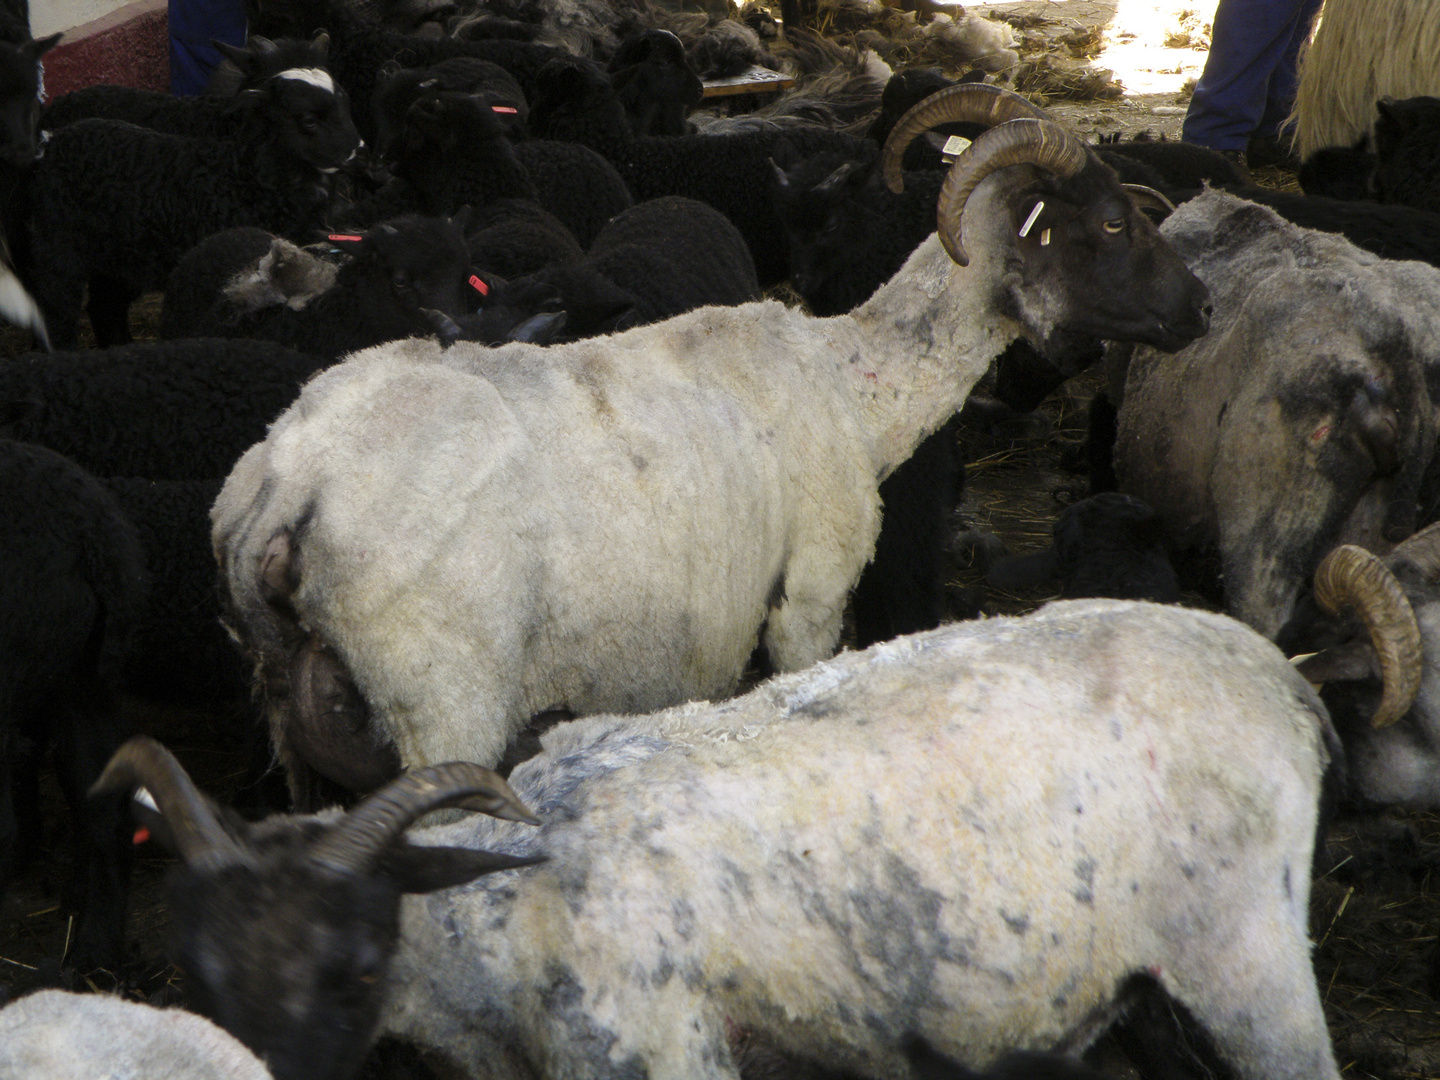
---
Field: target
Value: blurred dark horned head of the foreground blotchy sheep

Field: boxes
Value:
[91,736,543,1080]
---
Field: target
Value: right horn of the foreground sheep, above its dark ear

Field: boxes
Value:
[312,762,540,874]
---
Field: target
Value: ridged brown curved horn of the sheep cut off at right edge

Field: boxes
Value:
[1315,544,1423,727]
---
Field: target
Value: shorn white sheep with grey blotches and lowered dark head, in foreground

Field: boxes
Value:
[96,600,1339,1080]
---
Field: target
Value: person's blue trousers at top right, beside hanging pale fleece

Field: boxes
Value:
[1181,0,1320,150]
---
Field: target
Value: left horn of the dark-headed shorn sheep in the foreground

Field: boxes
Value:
[89,734,251,865]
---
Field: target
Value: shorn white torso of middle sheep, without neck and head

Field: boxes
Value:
[212,312,880,765]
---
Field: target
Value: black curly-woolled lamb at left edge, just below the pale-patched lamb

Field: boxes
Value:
[0,338,324,480]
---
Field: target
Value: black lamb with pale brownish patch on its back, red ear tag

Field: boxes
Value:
[163,207,478,360]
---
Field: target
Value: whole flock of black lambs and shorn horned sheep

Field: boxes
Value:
[0,0,1440,1080]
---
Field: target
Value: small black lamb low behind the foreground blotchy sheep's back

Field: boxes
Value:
[989,491,1179,603]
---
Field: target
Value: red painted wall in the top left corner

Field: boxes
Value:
[43,0,170,98]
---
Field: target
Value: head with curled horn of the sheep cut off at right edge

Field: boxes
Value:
[1276,526,1440,808]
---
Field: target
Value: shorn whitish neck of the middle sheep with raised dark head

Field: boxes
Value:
[841,235,1021,478]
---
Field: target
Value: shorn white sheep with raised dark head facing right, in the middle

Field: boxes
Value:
[213,85,1208,786]
